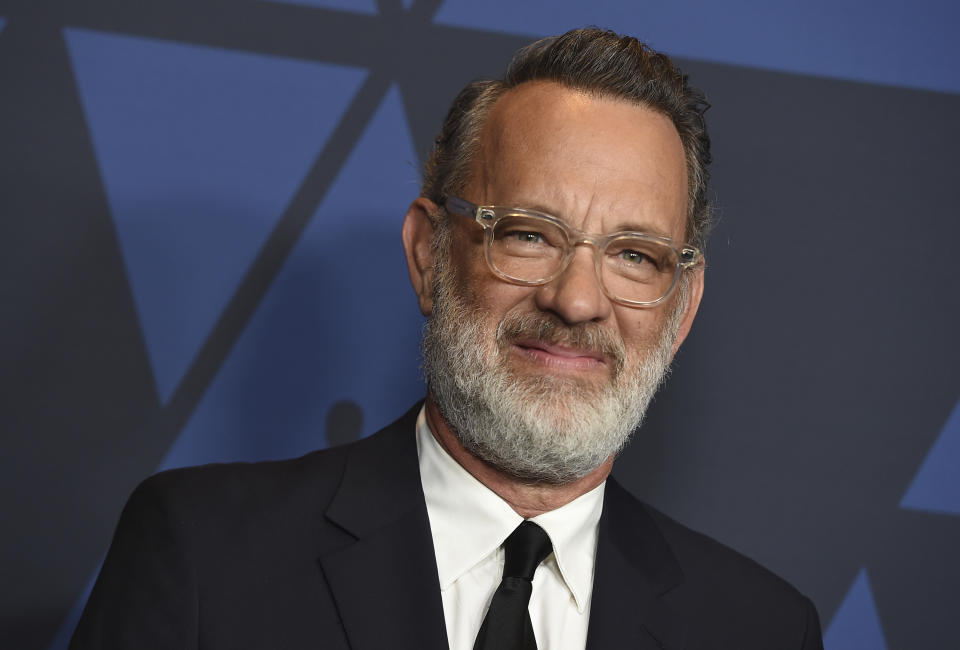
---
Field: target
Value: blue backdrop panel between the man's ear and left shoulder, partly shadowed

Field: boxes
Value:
[161,88,425,469]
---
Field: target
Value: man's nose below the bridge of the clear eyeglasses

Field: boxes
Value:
[536,245,612,325]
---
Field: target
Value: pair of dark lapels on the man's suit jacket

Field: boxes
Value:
[319,404,685,650]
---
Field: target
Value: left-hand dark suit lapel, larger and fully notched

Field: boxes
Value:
[319,405,447,650]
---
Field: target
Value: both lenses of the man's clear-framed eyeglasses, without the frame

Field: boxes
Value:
[490,215,680,302]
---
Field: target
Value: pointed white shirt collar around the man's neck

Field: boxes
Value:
[417,409,606,613]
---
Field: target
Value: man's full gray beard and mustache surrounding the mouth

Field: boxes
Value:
[421,255,685,484]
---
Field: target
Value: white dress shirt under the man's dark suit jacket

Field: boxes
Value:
[417,409,606,650]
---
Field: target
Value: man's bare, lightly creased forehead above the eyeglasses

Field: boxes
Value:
[465,82,687,238]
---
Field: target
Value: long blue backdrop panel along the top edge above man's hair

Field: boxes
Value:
[436,0,960,93]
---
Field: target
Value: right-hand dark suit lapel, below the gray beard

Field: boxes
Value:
[587,478,685,650]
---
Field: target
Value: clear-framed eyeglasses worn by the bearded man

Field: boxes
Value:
[445,197,703,307]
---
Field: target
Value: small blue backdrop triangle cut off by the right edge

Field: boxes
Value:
[900,402,960,515]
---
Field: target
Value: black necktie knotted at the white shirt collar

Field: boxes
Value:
[473,521,553,650]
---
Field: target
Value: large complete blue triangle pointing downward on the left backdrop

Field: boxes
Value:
[65,29,366,401]
